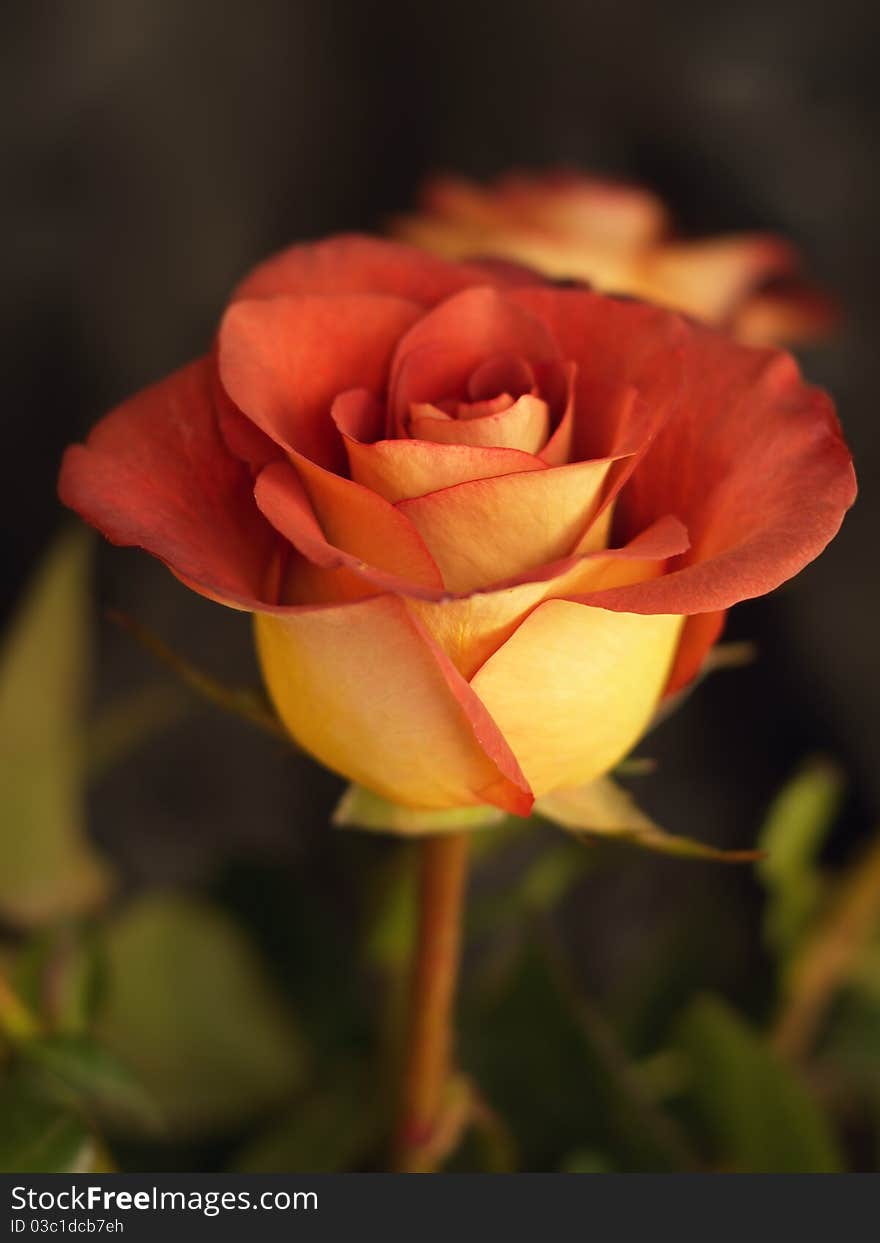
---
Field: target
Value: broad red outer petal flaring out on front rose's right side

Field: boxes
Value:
[581,340,855,614]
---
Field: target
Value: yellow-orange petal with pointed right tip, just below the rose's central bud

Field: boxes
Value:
[398,460,612,592]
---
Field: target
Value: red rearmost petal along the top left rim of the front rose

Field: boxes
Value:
[232,234,510,306]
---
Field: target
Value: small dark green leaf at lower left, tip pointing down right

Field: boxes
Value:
[22,1035,160,1131]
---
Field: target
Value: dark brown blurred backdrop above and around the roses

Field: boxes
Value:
[0,0,880,989]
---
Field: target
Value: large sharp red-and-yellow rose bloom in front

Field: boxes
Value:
[60,237,855,815]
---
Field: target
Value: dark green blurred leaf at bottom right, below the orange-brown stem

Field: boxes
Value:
[676,997,841,1173]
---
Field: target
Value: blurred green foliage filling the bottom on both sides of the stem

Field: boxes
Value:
[0,534,880,1173]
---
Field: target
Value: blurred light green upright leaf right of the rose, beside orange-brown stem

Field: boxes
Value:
[758,758,844,967]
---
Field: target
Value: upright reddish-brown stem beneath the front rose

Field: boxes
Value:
[394,833,469,1173]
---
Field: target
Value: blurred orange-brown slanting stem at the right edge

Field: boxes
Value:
[773,839,880,1058]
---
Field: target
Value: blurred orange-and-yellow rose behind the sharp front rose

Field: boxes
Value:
[394,173,836,346]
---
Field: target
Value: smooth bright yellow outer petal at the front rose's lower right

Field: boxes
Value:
[471,600,681,797]
